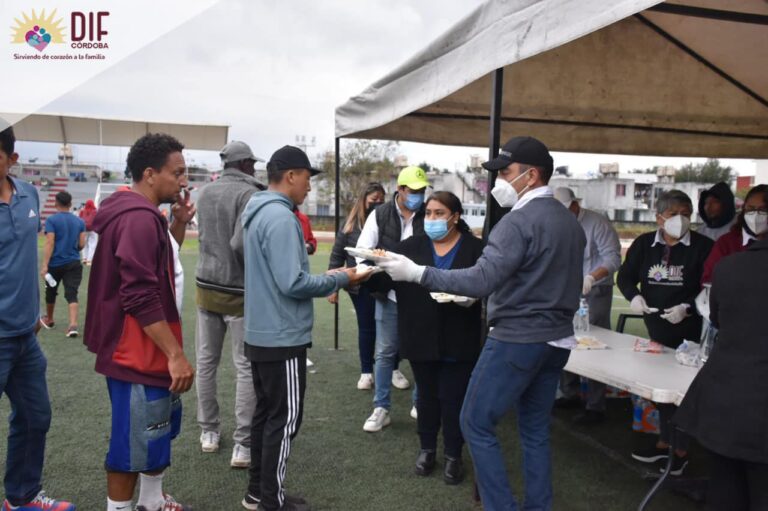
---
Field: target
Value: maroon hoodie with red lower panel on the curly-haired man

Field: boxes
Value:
[84,191,182,387]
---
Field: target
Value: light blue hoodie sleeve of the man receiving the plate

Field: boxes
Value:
[261,214,349,300]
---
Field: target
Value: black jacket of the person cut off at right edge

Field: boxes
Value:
[673,240,768,463]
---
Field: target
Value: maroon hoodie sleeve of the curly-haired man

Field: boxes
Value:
[115,210,166,327]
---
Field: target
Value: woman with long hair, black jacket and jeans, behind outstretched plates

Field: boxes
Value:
[328,183,386,390]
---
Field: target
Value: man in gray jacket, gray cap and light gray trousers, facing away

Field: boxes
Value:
[195,141,265,468]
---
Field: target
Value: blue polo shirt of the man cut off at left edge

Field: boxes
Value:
[0,177,40,338]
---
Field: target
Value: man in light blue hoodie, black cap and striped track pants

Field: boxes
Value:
[240,146,369,511]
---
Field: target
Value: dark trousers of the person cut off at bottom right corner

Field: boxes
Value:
[706,452,768,511]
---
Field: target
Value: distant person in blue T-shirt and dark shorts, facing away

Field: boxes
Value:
[40,192,85,337]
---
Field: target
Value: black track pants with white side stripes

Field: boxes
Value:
[248,350,307,511]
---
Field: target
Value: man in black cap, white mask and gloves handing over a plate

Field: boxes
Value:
[379,137,586,511]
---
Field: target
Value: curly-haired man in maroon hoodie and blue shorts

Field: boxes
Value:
[85,134,194,511]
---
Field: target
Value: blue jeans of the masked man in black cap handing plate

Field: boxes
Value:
[461,337,571,511]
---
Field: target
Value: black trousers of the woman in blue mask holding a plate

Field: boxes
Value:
[411,361,475,458]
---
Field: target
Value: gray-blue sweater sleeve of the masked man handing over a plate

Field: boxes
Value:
[421,217,528,298]
